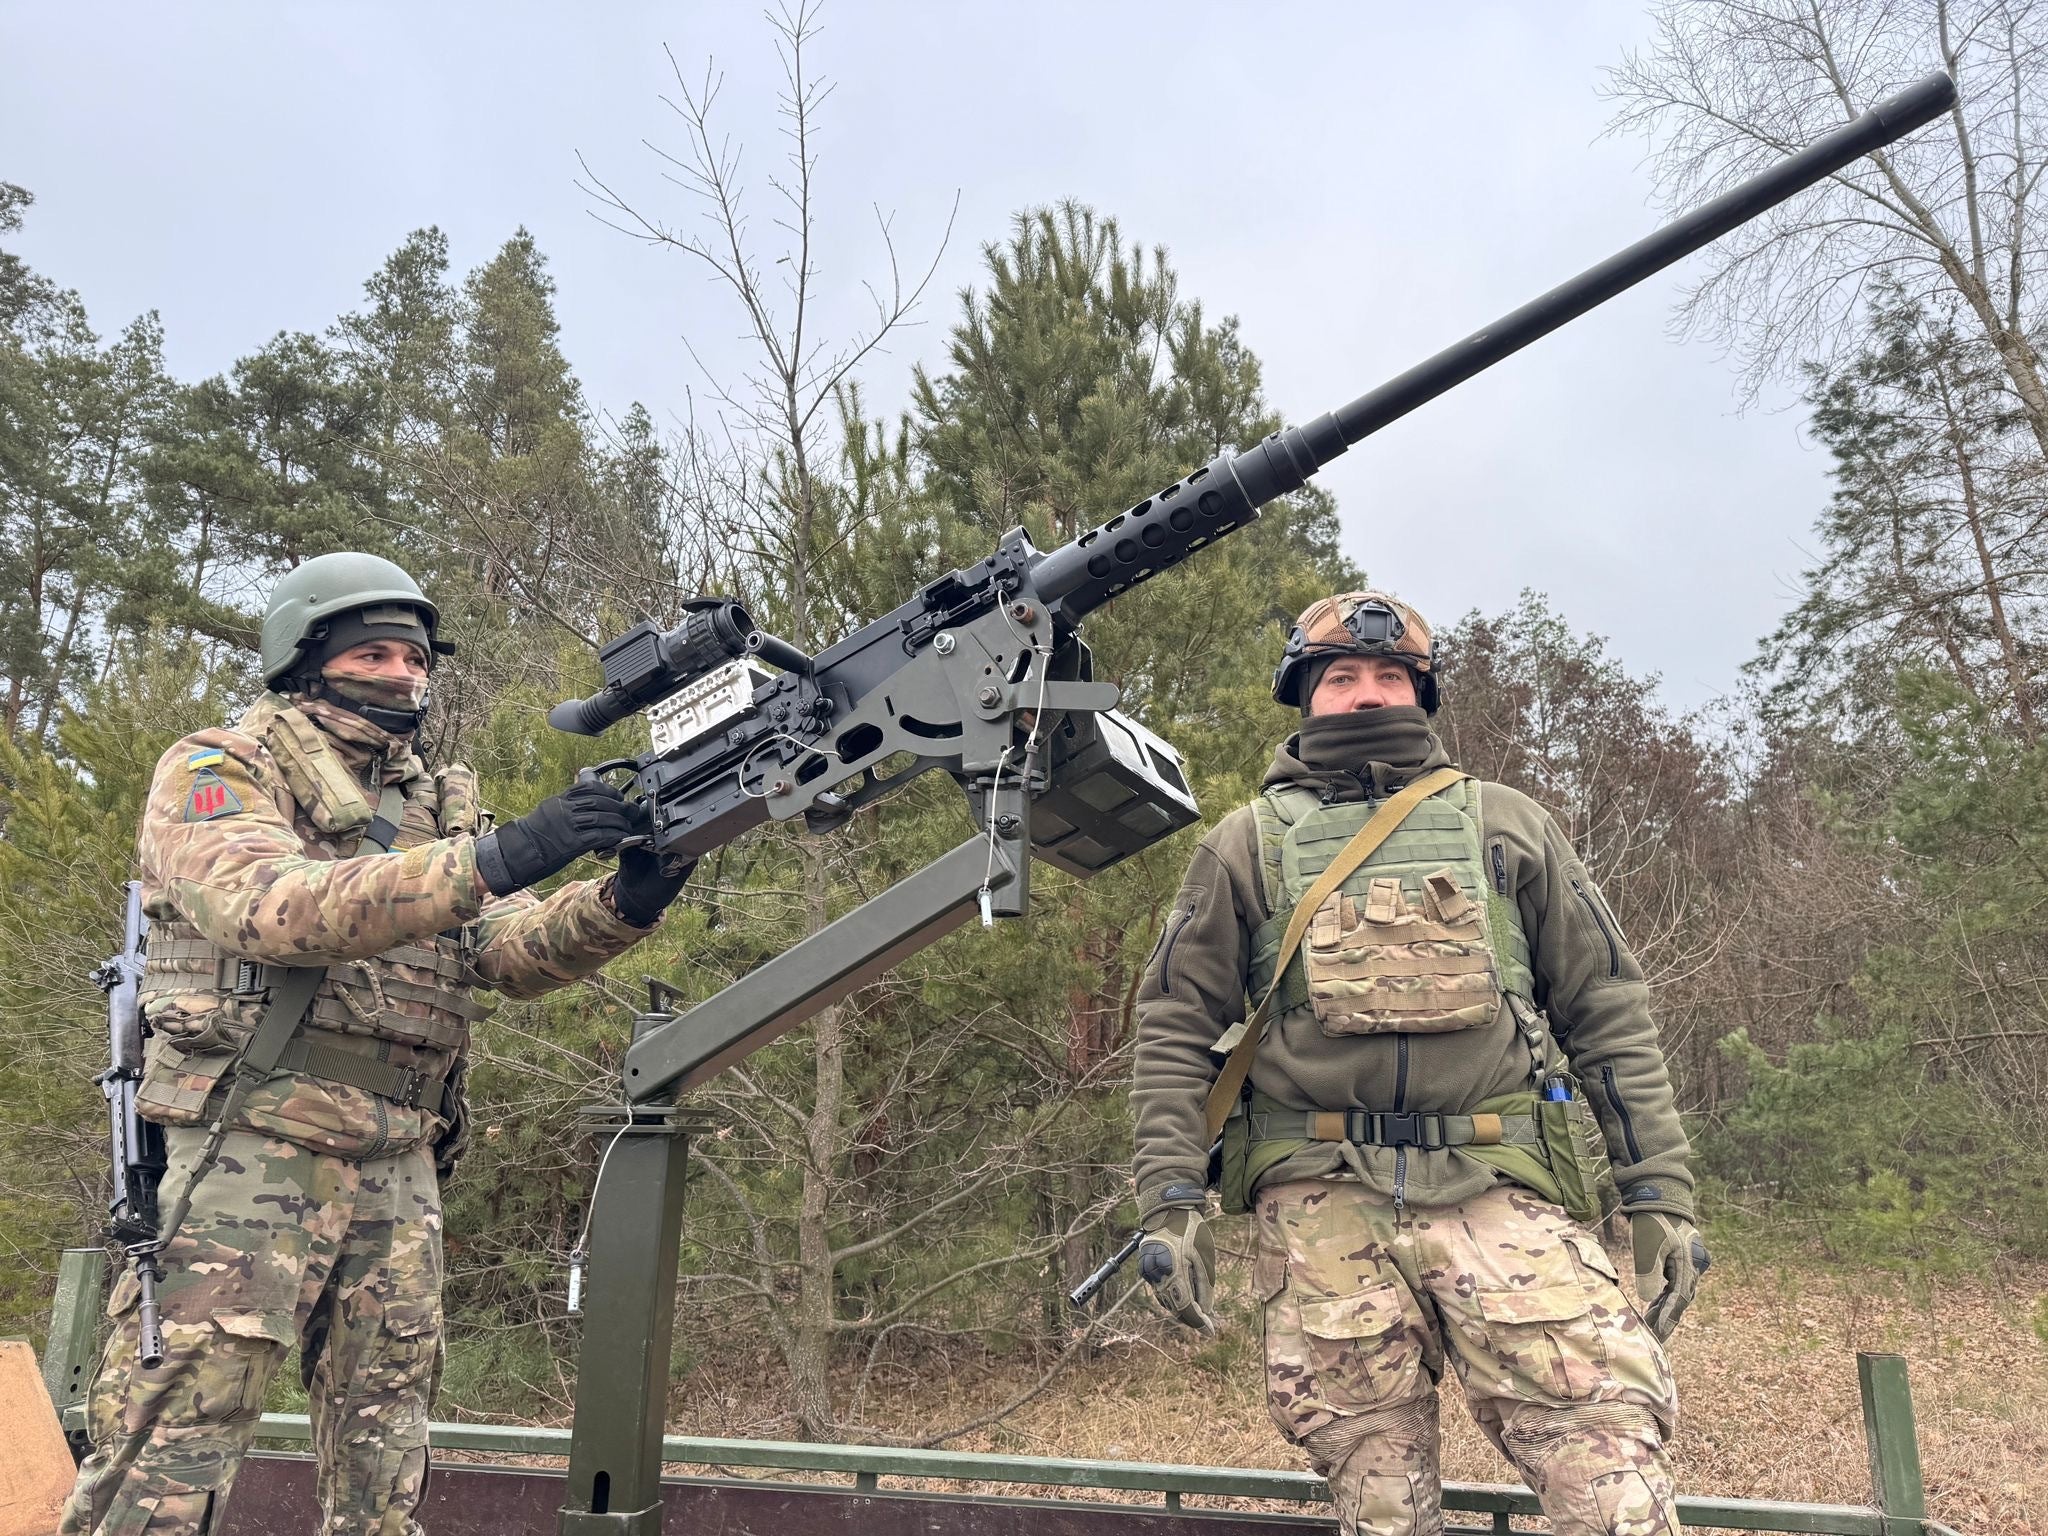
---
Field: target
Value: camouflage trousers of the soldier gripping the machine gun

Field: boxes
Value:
[61,1130,440,1536]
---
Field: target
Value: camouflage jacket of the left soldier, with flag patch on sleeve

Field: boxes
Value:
[137,694,649,1157]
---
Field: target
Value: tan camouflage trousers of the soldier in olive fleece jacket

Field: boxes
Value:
[1253,1180,1679,1536]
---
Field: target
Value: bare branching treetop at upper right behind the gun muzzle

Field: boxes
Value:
[1608,0,2048,453]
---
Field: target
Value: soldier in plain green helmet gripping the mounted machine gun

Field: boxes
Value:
[63,553,686,1536]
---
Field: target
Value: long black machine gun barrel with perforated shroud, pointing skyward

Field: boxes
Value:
[1032,72,1956,625]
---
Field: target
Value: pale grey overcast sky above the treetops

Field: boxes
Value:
[0,0,1827,709]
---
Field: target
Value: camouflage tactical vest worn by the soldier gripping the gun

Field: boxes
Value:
[137,696,489,1147]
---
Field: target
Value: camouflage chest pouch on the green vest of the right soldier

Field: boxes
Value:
[1303,866,1501,1036]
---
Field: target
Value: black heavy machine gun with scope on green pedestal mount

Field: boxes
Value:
[549,74,1956,1536]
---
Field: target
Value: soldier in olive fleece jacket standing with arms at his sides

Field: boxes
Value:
[1130,592,1706,1536]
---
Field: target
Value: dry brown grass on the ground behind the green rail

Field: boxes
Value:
[672,1264,2048,1536]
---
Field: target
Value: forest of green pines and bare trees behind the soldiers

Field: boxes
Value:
[0,0,2048,1515]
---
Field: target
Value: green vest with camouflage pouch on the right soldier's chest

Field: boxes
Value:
[1249,778,1536,1036]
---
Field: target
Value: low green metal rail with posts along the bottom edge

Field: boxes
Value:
[43,1249,1960,1536]
